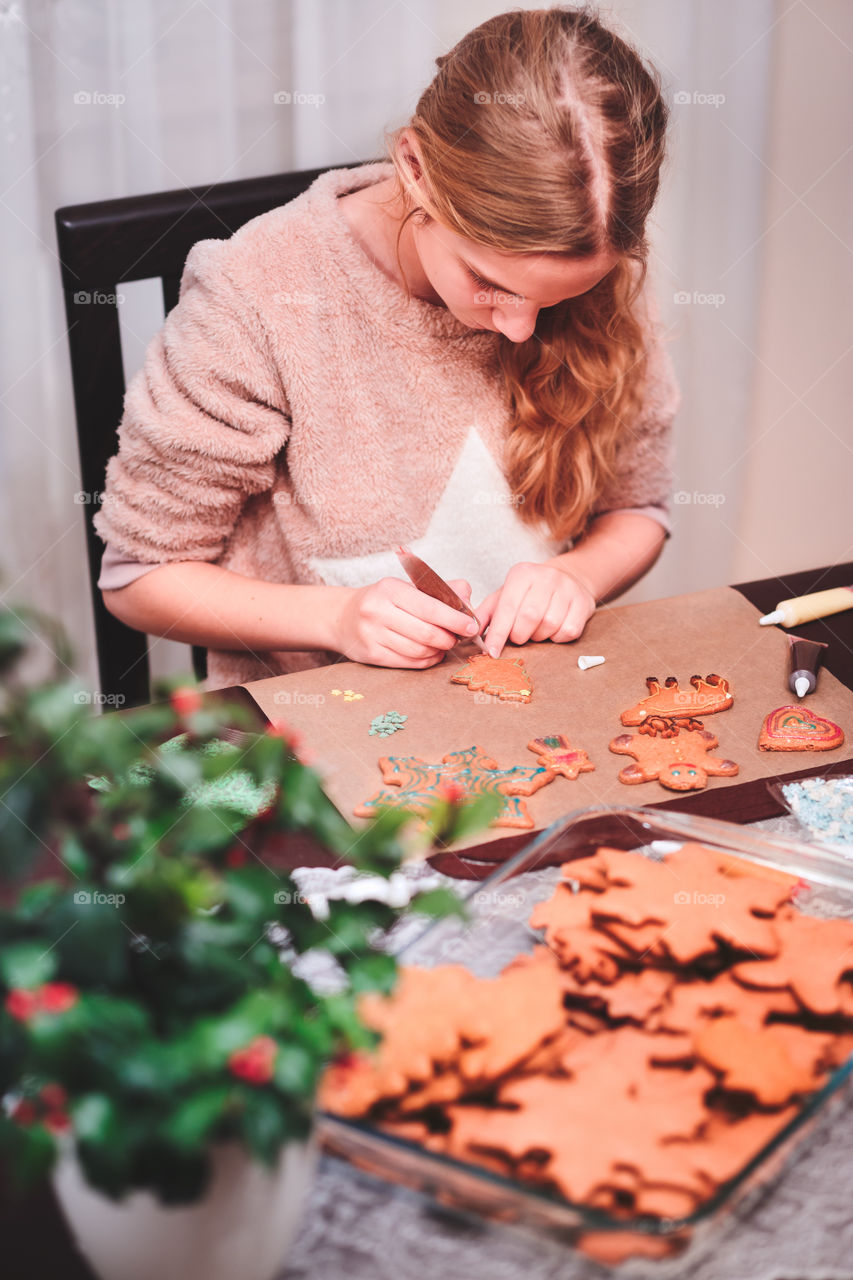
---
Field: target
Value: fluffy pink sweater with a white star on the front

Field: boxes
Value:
[95,161,679,689]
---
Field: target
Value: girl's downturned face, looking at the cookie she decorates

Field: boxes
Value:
[409,220,619,342]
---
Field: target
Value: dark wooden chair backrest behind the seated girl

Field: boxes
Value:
[55,165,358,707]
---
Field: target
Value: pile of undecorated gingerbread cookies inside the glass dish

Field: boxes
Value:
[321,839,853,1256]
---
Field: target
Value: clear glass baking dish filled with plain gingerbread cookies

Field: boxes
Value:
[319,806,853,1274]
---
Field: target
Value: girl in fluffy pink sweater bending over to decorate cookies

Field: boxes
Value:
[96,8,679,689]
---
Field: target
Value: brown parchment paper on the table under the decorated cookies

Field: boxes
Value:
[236,586,853,850]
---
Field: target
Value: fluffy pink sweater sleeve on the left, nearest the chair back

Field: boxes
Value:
[95,241,291,566]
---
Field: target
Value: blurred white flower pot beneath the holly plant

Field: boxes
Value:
[54,1138,316,1280]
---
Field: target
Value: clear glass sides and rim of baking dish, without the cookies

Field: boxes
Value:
[318,805,853,1275]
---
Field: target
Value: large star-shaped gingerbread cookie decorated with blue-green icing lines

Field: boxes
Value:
[353,746,555,827]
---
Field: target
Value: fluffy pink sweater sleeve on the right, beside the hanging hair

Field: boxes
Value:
[584,291,681,532]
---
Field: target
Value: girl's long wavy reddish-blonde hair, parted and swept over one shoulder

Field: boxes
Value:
[386,6,669,540]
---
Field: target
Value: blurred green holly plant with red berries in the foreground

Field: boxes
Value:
[0,608,498,1203]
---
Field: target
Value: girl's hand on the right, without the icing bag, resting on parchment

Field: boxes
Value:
[475,563,596,657]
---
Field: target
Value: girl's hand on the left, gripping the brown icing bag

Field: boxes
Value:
[332,577,476,667]
